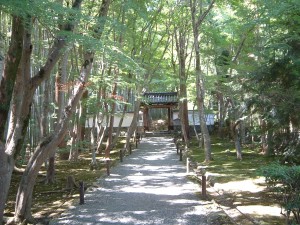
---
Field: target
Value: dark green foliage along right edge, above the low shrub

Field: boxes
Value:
[239,1,300,161]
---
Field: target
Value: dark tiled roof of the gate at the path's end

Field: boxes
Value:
[143,92,178,105]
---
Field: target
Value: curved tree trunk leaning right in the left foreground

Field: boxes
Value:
[14,53,93,221]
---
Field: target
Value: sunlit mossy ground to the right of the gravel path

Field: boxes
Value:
[191,138,285,225]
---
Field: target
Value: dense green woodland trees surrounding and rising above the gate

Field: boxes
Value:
[0,0,300,223]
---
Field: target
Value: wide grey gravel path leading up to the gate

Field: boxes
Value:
[50,137,217,225]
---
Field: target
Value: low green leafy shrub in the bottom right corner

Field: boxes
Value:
[259,163,300,224]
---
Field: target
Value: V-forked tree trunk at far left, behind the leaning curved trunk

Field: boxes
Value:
[0,0,82,221]
